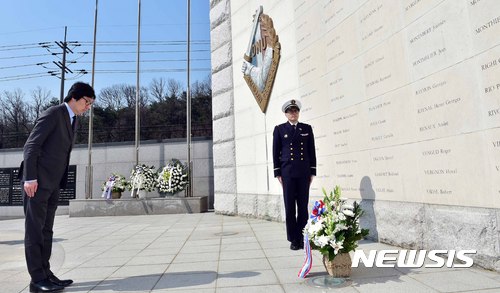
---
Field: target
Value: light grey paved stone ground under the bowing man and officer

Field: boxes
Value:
[0,213,500,293]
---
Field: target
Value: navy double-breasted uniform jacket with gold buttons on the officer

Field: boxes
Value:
[273,122,316,177]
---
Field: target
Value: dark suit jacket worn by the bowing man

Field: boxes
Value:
[19,104,77,189]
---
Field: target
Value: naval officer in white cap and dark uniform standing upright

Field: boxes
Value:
[273,100,316,250]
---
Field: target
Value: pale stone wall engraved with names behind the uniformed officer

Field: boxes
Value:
[212,0,500,269]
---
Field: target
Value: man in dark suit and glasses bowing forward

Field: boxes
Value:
[20,82,95,292]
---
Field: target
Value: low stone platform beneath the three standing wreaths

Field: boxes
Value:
[69,196,208,217]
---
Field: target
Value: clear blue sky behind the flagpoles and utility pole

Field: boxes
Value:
[0,0,210,99]
